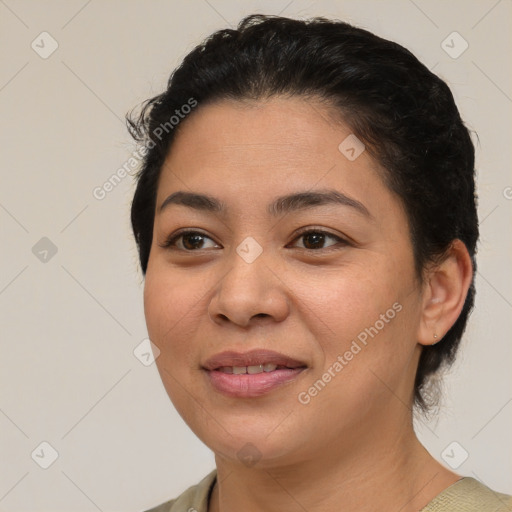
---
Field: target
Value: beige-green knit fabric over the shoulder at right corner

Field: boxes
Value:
[421,477,512,512]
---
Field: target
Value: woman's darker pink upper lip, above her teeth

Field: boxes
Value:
[203,349,307,370]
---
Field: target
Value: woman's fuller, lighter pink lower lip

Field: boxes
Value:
[206,368,305,398]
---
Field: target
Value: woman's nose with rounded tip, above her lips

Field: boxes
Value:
[208,247,289,328]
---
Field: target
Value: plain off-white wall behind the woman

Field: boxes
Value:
[0,0,512,512]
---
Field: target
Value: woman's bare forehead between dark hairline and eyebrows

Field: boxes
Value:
[159,97,381,202]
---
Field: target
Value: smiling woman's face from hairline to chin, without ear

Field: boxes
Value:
[144,98,422,464]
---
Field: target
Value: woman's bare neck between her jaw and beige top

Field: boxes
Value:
[209,412,460,512]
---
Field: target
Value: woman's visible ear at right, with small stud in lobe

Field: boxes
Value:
[417,240,473,345]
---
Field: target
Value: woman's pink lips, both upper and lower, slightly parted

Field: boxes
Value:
[203,350,307,398]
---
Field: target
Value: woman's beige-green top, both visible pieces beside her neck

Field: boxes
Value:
[146,470,512,512]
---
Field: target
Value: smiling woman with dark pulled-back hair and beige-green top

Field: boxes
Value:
[129,15,512,512]
